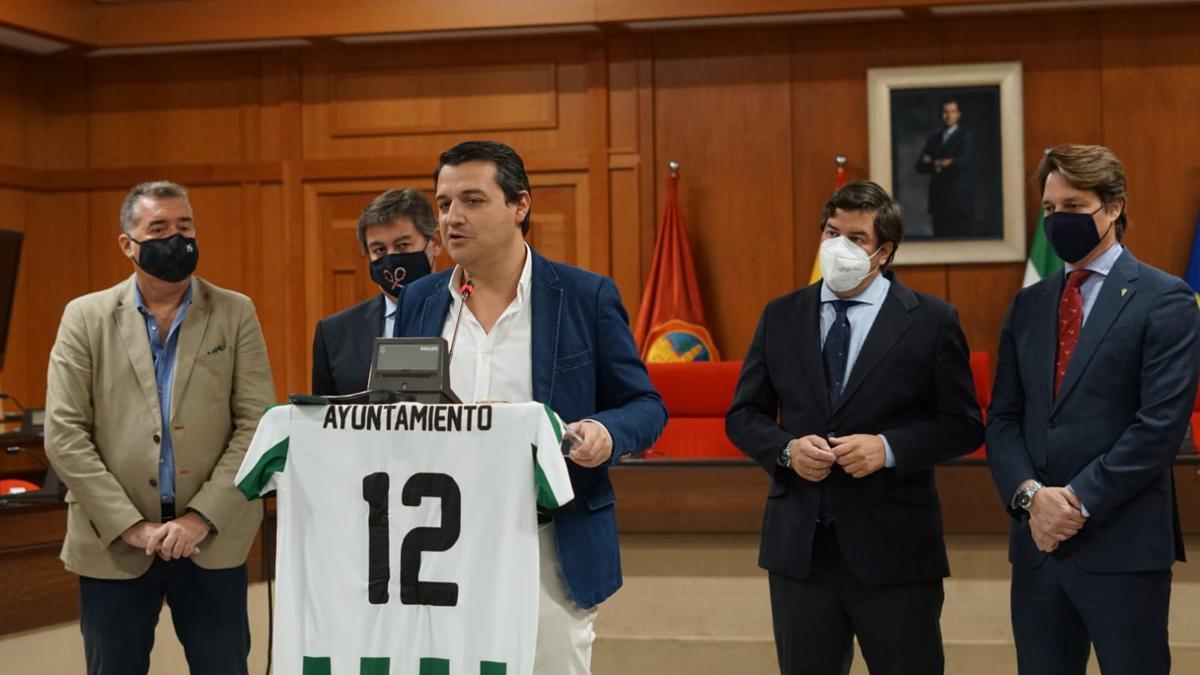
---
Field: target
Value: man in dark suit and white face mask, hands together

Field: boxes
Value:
[725,181,983,675]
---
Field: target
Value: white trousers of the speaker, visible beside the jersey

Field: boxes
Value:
[533,522,596,675]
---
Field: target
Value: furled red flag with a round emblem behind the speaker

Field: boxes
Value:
[634,174,720,363]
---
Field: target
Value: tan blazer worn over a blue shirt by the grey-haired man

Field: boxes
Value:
[46,276,275,579]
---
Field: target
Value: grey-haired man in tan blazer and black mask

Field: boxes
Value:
[46,181,275,675]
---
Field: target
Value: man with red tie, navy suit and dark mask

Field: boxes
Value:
[988,145,1200,675]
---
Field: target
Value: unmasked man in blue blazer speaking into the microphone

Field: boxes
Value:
[400,141,667,675]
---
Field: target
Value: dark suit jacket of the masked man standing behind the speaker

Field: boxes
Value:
[312,293,384,396]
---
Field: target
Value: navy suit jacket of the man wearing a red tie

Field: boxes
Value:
[988,250,1200,573]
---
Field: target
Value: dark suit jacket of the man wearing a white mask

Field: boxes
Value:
[725,273,983,585]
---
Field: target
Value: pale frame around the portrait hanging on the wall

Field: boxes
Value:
[866,61,1026,265]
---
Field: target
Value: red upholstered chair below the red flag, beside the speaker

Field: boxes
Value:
[646,362,745,460]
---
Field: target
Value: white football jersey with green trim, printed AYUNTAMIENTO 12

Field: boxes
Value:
[236,402,574,675]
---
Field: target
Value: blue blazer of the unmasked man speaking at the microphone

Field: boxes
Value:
[400,249,667,608]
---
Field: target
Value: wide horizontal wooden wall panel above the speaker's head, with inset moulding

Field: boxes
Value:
[304,38,590,163]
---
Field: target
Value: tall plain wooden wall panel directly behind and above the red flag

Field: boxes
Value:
[648,30,794,359]
